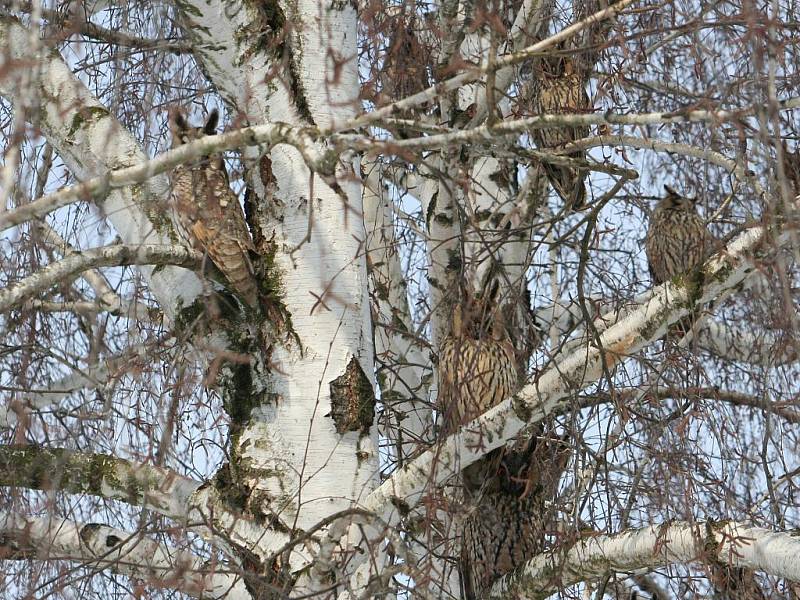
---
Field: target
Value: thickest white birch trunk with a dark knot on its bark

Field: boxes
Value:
[172,1,378,584]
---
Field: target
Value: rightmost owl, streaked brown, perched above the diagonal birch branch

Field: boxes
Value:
[645,186,715,335]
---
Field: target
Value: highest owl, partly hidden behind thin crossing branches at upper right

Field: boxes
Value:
[531,57,591,210]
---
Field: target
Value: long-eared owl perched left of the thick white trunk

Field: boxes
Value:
[170,110,258,307]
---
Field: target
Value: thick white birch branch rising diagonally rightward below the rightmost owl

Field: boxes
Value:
[364,214,776,520]
